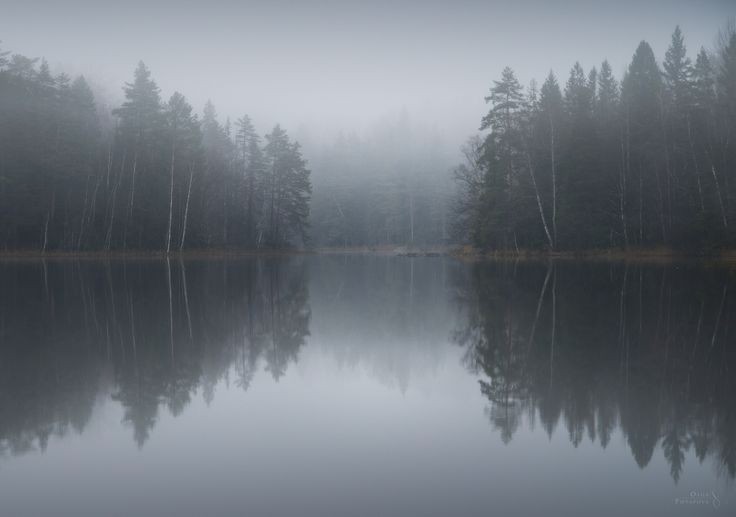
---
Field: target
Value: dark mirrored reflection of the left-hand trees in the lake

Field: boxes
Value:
[0,259,311,454]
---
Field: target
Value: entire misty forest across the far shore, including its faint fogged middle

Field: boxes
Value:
[0,26,736,253]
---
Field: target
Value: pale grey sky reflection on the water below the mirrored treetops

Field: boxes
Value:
[0,342,736,517]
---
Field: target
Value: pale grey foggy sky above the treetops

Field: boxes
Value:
[0,0,736,145]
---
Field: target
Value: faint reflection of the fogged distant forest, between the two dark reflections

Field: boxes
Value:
[300,256,457,390]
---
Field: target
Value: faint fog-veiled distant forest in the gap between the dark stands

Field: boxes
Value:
[304,122,457,248]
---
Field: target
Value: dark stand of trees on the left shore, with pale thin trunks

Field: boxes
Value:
[0,46,311,253]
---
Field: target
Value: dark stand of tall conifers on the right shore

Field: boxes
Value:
[454,26,736,251]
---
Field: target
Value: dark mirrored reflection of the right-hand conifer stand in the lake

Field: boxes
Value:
[454,263,736,481]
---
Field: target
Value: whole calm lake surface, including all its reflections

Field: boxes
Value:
[0,256,736,517]
